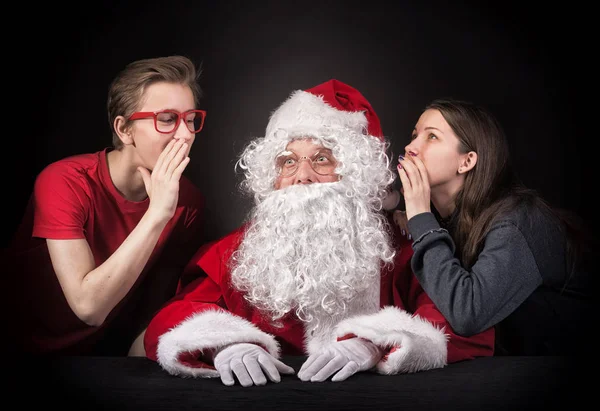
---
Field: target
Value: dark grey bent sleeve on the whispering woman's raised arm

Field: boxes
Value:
[408,213,542,336]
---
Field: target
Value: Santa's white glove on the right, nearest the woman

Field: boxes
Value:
[298,338,383,382]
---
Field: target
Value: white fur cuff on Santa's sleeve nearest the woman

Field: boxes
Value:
[336,306,448,374]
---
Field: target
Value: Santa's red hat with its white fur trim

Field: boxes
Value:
[266,79,383,140]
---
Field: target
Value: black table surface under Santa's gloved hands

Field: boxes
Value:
[14,357,584,411]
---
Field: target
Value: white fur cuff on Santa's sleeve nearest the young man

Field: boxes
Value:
[156,310,279,378]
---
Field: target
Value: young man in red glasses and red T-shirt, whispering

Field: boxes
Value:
[3,56,206,355]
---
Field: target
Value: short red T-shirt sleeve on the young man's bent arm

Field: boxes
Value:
[33,164,90,239]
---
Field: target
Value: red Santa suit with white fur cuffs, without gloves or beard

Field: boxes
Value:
[144,227,494,377]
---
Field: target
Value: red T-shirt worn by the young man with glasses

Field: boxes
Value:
[3,148,204,355]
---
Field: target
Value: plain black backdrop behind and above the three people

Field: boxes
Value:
[2,0,598,248]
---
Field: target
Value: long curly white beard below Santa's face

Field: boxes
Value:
[231,179,394,324]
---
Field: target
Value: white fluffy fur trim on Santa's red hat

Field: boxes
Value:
[266,90,367,138]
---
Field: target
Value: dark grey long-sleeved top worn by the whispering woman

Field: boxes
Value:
[408,206,592,355]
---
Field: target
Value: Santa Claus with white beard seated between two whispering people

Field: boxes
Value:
[144,80,494,386]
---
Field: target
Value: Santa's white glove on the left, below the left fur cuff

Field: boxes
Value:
[214,343,294,387]
